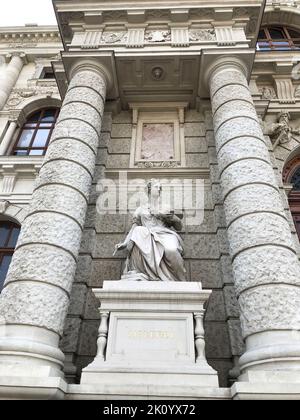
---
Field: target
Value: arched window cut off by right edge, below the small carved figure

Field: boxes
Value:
[283,156,300,240]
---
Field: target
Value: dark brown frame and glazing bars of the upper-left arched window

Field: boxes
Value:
[10,107,60,157]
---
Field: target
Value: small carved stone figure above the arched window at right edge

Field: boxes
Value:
[264,111,300,149]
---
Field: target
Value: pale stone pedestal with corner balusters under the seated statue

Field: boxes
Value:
[81,280,218,397]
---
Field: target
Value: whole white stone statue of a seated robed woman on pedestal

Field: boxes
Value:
[114,179,186,281]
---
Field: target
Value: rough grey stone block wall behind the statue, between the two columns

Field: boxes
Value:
[61,106,240,386]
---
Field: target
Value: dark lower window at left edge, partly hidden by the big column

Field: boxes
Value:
[0,220,20,292]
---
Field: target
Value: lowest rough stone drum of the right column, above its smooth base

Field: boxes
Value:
[239,284,300,338]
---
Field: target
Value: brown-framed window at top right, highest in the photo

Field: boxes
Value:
[257,26,300,51]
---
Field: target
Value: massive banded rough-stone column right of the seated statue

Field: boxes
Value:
[207,58,300,377]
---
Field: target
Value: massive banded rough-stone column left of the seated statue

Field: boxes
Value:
[0,60,107,376]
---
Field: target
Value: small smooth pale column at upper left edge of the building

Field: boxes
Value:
[0,53,26,111]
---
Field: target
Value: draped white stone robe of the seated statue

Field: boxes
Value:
[125,207,185,281]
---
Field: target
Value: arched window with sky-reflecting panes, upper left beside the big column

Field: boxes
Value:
[12,108,59,156]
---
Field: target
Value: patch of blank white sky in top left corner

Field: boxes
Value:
[0,0,56,26]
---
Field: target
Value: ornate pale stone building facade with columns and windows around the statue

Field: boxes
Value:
[0,0,300,399]
